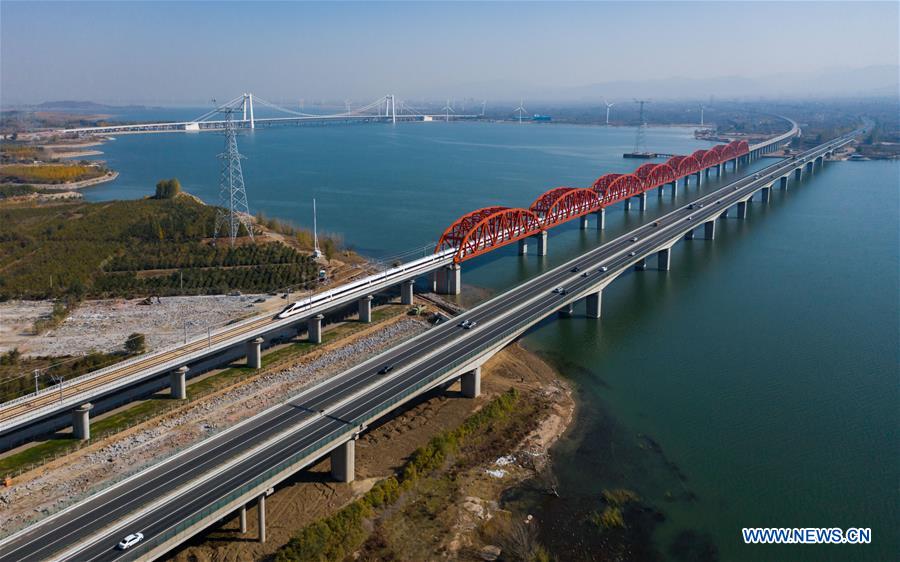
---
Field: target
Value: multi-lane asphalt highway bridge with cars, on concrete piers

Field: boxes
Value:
[0,128,857,562]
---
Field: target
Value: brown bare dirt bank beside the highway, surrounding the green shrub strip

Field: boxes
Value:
[171,345,574,562]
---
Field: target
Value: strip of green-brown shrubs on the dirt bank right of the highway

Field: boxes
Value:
[275,388,536,562]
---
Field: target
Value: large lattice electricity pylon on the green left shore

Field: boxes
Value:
[213,108,253,246]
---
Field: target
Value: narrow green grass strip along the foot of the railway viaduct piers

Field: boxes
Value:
[0,305,408,477]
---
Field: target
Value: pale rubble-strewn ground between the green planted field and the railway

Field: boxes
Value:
[0,295,270,356]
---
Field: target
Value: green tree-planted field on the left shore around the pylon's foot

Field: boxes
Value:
[0,196,319,300]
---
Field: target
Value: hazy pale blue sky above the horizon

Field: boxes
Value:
[0,0,898,104]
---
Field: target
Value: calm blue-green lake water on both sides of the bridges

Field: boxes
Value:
[86,123,900,561]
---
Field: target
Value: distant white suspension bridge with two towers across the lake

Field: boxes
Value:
[42,93,482,135]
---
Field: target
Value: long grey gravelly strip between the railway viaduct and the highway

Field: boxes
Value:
[0,310,427,532]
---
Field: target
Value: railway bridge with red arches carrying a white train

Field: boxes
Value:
[0,116,800,449]
